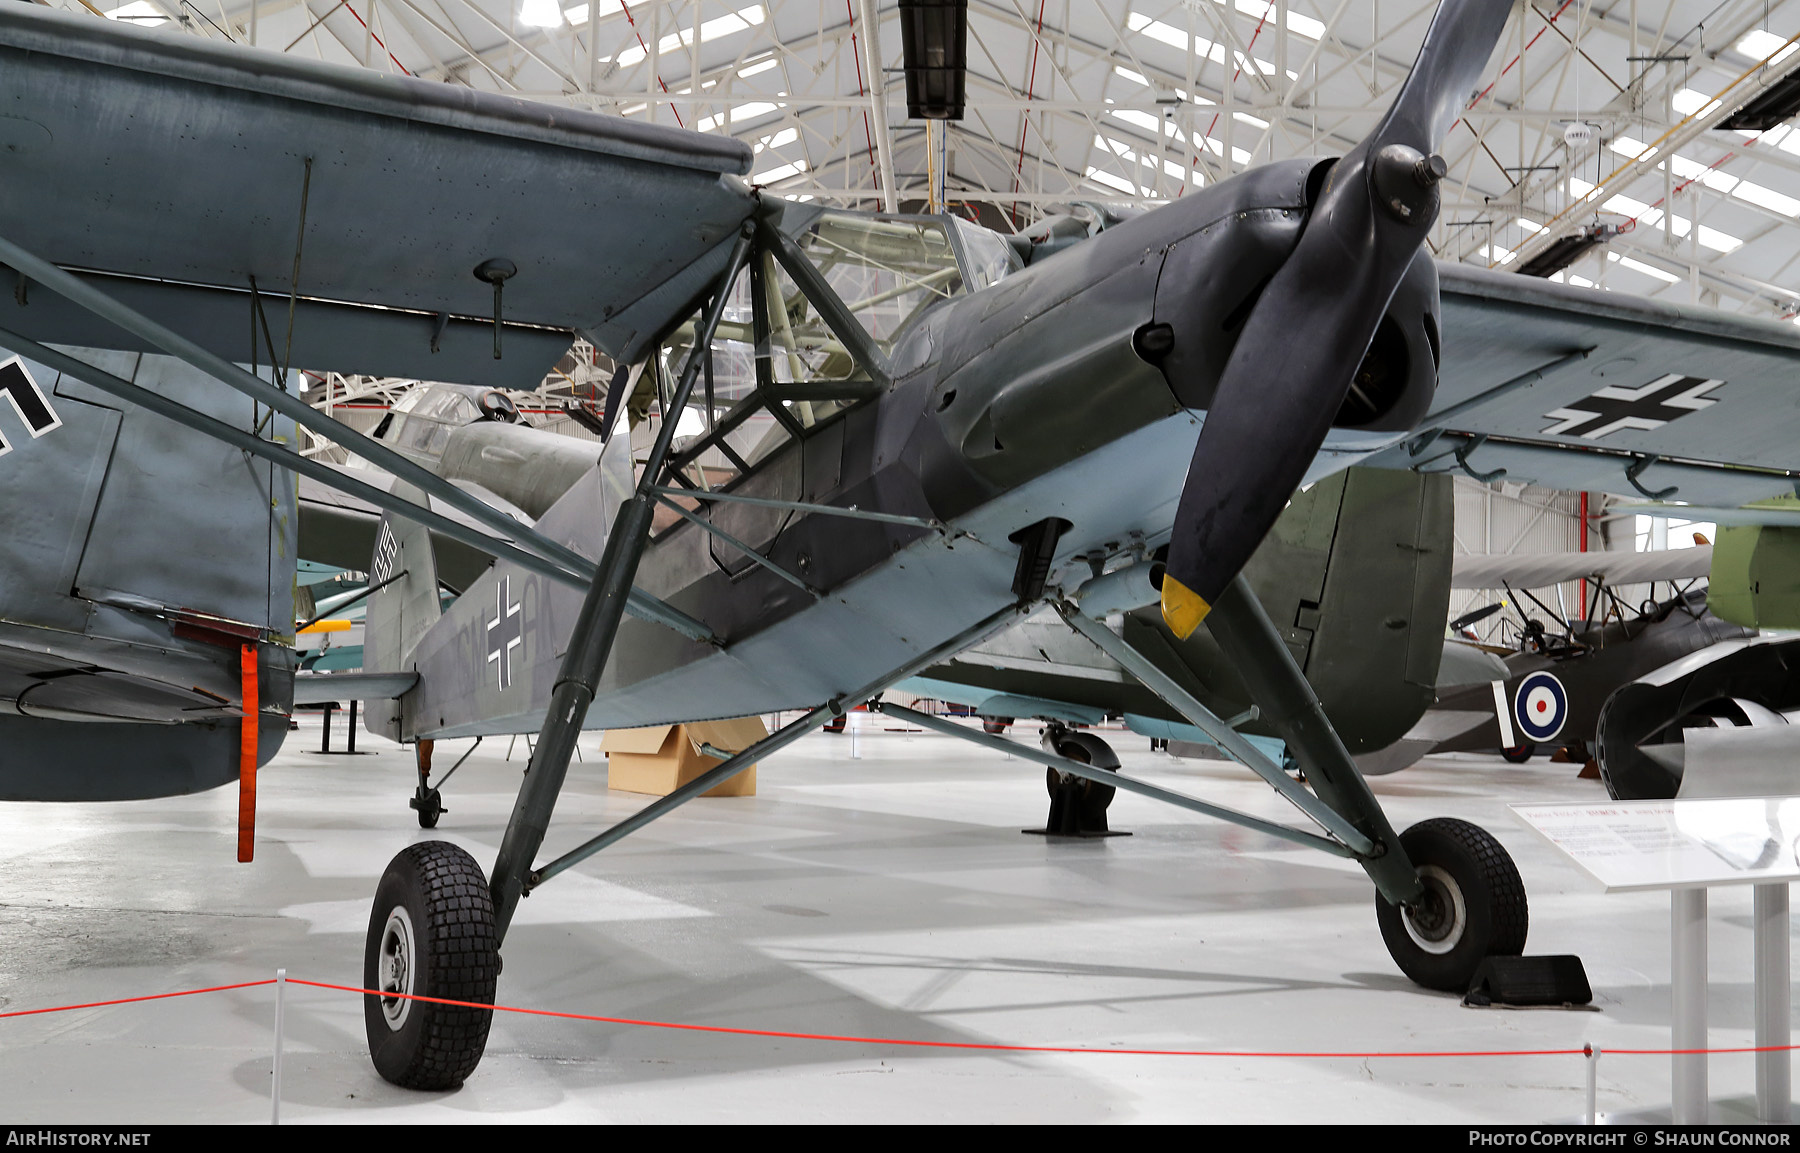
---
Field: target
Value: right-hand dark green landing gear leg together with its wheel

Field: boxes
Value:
[1206,577,1530,993]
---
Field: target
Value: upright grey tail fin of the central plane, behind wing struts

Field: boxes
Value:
[362,482,443,741]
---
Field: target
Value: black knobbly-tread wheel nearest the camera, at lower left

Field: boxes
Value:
[362,840,500,1088]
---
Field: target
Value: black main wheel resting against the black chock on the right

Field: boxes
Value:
[1375,817,1530,993]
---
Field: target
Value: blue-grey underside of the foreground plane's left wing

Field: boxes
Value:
[0,4,756,387]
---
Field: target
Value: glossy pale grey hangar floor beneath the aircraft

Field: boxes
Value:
[0,716,1778,1122]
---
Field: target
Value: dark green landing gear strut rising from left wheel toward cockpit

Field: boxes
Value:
[488,223,756,943]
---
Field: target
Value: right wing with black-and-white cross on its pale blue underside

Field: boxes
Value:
[1368,264,1800,505]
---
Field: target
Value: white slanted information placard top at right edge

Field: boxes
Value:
[1510,797,1800,892]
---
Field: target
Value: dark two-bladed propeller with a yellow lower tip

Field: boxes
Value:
[1163,0,1512,637]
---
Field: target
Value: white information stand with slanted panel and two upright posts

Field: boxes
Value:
[1510,797,1800,1124]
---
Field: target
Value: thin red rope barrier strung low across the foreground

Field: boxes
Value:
[0,977,1800,1059]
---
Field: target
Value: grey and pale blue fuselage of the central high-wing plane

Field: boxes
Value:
[396,162,1436,737]
